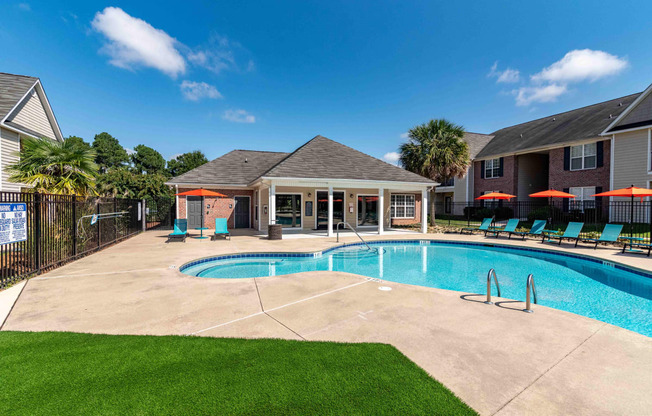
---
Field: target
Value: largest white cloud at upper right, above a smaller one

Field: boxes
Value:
[531,49,628,83]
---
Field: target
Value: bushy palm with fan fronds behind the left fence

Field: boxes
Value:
[6,137,97,195]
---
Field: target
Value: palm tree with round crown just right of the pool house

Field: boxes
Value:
[399,119,469,225]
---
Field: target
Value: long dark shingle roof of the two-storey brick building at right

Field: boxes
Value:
[476,93,640,158]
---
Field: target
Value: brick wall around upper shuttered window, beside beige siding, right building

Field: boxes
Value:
[548,140,611,191]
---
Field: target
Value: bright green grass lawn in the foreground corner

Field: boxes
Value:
[0,332,475,415]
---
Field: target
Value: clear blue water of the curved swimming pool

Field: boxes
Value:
[181,241,652,336]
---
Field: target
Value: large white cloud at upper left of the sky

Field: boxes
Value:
[91,7,186,78]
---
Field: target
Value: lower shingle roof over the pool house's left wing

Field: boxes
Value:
[169,150,288,185]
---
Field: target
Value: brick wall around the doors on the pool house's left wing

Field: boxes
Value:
[179,188,254,229]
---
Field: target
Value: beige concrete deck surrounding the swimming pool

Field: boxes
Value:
[0,231,652,415]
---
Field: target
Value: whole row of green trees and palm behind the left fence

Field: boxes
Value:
[7,132,208,198]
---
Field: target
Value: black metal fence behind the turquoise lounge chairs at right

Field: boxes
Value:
[435,198,652,242]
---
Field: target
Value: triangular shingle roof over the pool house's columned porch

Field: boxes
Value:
[262,136,434,184]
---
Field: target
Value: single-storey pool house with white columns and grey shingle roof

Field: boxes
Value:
[167,136,436,236]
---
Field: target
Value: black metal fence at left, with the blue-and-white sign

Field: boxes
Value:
[0,192,143,288]
